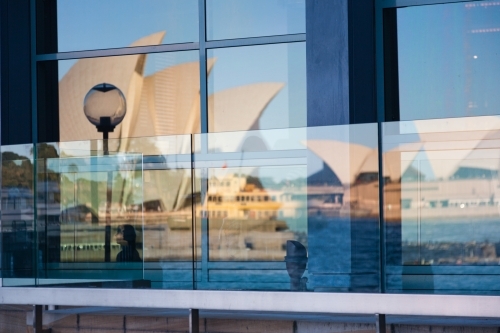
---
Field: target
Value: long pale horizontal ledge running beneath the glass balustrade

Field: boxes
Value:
[0,287,500,318]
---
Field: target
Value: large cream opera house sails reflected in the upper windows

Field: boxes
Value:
[59,32,283,143]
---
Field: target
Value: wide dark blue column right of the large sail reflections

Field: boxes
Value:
[306,0,379,292]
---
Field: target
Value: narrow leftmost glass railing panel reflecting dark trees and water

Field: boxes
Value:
[1,144,36,286]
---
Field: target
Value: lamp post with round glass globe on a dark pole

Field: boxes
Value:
[83,83,127,262]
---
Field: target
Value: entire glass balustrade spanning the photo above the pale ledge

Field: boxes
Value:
[1,116,500,294]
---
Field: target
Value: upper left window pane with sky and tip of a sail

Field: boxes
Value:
[49,0,199,52]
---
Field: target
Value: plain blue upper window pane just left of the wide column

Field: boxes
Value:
[207,0,306,40]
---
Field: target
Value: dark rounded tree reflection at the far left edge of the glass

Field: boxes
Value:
[2,152,33,189]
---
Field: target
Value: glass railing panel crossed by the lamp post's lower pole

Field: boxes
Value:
[32,135,193,289]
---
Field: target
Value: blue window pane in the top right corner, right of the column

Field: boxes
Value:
[397,1,500,120]
